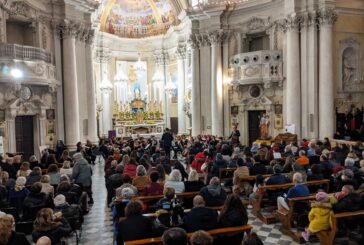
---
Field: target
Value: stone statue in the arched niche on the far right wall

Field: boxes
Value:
[342,47,357,88]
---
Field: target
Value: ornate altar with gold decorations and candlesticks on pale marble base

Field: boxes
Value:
[113,97,164,138]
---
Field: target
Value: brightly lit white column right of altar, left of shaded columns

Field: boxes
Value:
[177,46,186,134]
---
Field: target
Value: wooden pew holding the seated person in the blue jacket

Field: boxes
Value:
[252,179,330,224]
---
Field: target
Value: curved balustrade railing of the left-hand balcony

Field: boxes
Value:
[0,43,53,64]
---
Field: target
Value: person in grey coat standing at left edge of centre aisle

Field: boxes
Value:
[72,152,94,204]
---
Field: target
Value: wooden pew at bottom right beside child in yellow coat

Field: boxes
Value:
[316,210,364,245]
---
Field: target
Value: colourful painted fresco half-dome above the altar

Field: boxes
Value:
[99,0,177,38]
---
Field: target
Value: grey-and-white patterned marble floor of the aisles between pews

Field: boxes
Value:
[73,159,359,245]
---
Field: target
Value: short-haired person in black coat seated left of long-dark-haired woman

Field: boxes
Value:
[183,195,217,232]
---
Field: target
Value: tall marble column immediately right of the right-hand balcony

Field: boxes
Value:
[286,16,301,138]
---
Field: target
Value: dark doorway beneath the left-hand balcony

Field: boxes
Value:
[15,116,34,159]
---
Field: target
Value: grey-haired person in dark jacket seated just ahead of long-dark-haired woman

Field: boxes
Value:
[199,177,226,207]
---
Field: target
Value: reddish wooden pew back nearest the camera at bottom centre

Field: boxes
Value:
[124,225,253,245]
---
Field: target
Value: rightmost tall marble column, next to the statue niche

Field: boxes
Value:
[319,9,337,139]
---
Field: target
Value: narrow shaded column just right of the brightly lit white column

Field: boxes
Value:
[189,35,201,136]
